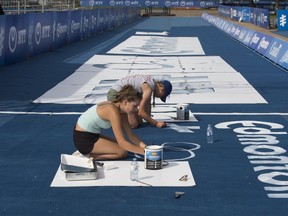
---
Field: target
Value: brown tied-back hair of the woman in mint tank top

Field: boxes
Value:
[113,85,142,103]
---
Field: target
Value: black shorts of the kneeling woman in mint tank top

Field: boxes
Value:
[73,129,100,155]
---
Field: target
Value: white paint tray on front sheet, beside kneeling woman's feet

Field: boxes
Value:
[61,154,97,181]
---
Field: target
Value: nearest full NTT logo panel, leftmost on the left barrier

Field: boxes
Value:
[4,14,29,65]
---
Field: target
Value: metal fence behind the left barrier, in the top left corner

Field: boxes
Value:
[0,0,80,15]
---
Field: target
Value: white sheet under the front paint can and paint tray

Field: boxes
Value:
[50,161,196,187]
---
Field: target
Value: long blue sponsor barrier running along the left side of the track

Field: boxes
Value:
[0,7,140,67]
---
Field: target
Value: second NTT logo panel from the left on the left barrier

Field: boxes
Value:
[27,12,55,56]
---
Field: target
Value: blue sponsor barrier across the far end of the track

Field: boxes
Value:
[80,0,218,8]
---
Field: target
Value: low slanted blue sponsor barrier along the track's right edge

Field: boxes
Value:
[202,13,288,70]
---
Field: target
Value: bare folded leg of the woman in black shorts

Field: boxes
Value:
[90,135,128,160]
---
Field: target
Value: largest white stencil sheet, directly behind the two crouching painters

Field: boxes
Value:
[34,55,267,106]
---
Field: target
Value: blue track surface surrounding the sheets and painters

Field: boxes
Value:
[0,17,288,216]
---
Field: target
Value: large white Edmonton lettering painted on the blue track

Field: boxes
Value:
[215,120,288,198]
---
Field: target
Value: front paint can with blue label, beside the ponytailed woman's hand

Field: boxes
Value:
[144,145,163,170]
